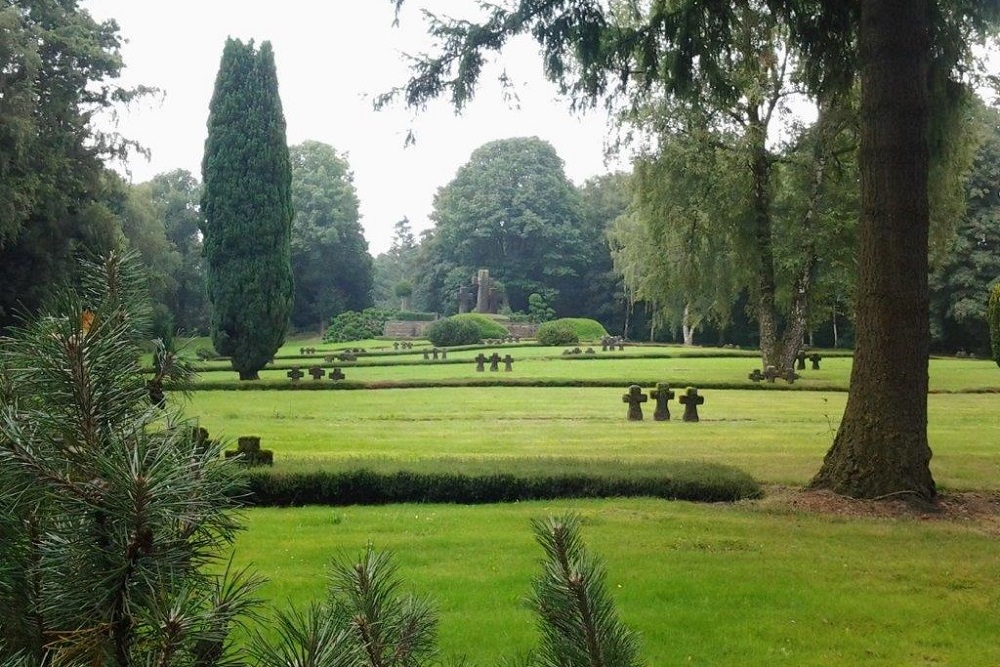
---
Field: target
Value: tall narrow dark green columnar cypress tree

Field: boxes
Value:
[201,39,293,380]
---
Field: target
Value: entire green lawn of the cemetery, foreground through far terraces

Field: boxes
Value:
[178,344,1000,666]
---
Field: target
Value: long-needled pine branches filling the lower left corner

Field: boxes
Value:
[0,253,258,667]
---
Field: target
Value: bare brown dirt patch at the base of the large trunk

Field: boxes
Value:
[756,486,1000,535]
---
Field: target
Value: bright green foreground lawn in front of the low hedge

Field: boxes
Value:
[235,499,1000,667]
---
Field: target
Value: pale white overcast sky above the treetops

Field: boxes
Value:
[81,0,620,255]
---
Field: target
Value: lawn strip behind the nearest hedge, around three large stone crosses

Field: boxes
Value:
[186,387,1000,489]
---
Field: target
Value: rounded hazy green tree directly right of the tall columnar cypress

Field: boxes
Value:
[290,141,373,331]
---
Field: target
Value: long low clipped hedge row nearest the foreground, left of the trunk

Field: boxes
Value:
[238,468,762,507]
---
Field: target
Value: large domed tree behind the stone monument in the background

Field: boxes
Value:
[417,137,589,312]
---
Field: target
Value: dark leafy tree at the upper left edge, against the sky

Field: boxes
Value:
[0,0,148,328]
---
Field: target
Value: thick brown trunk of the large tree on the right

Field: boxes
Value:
[811,0,935,500]
